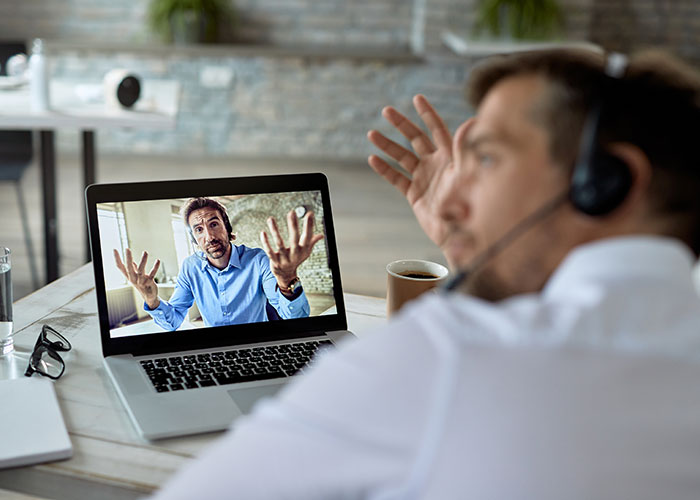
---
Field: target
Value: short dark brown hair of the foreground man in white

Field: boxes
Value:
[467,49,700,255]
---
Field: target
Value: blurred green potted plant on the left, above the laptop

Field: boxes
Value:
[148,0,233,44]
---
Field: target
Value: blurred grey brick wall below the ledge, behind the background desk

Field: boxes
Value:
[42,49,470,159]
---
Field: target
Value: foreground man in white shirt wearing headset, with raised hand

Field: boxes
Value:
[152,51,700,500]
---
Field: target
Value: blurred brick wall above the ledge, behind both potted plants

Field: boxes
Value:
[0,0,700,65]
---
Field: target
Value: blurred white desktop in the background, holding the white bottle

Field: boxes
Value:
[0,80,180,130]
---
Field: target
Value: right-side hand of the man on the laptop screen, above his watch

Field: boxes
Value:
[260,210,323,289]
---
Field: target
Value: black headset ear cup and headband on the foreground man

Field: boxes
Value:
[569,53,632,216]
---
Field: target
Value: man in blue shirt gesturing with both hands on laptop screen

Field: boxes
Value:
[114,198,323,330]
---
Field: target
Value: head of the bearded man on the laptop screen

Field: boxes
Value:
[182,198,236,259]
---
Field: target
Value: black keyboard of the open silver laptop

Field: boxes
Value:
[140,340,332,392]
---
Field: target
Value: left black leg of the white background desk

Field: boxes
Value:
[39,130,58,283]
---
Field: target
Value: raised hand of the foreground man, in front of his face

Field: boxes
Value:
[367,95,460,246]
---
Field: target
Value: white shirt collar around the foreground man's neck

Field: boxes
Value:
[543,235,695,297]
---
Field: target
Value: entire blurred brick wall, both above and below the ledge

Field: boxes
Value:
[0,0,700,160]
